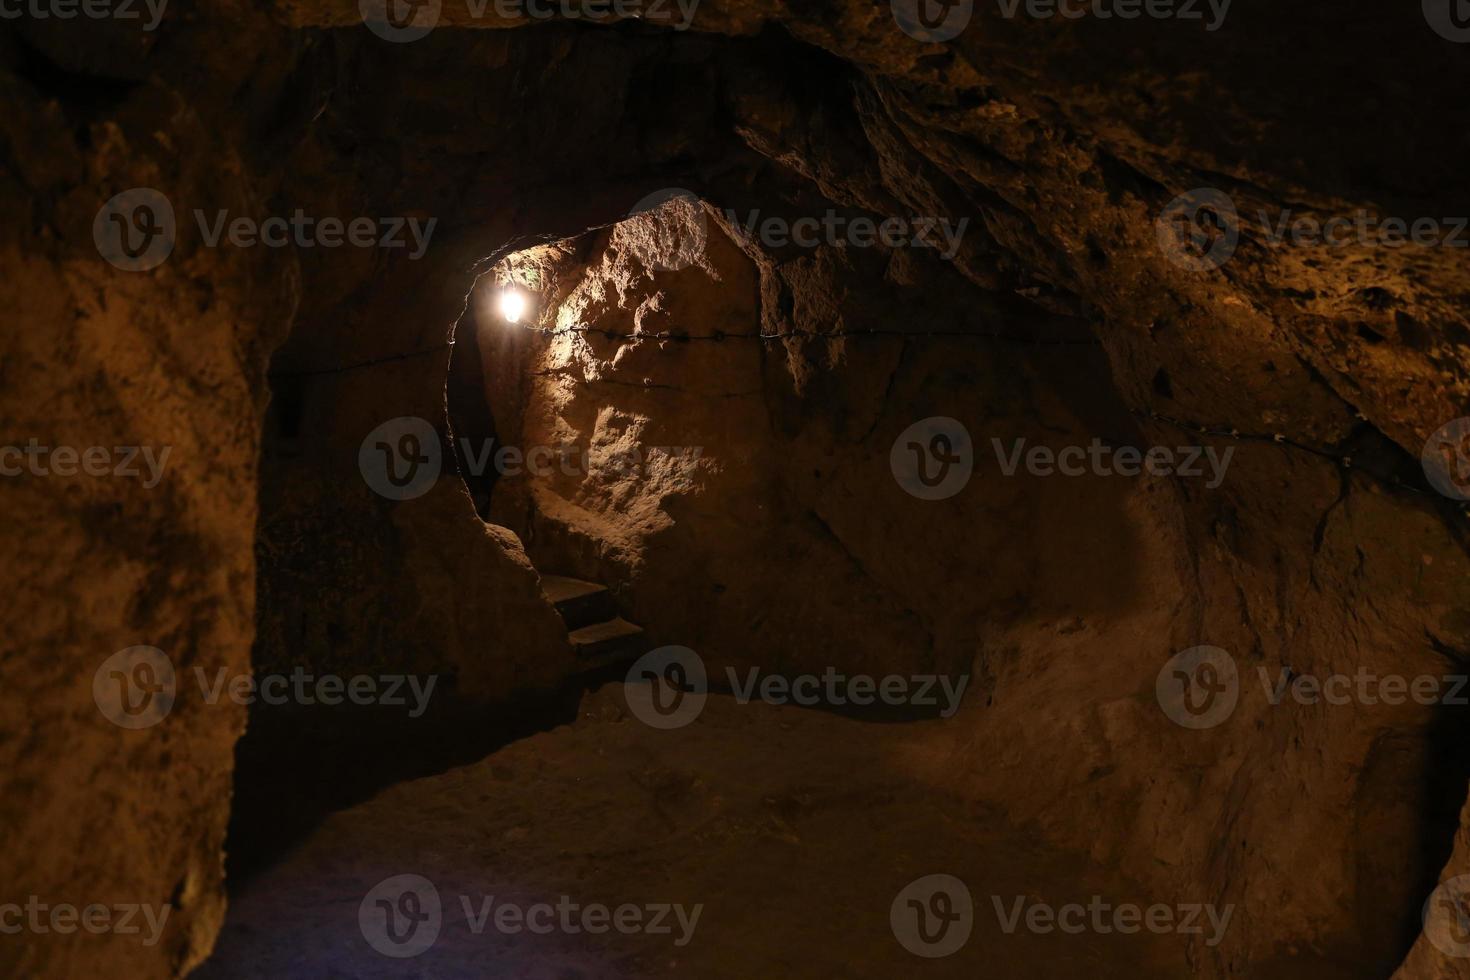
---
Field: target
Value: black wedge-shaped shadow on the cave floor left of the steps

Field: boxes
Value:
[226,686,582,893]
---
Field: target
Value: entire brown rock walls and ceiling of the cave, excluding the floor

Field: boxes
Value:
[0,3,1470,979]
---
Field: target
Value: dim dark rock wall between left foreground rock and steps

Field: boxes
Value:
[256,246,572,701]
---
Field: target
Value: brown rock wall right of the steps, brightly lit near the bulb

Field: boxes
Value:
[458,195,1467,976]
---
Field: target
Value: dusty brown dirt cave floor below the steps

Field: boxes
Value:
[196,683,1191,980]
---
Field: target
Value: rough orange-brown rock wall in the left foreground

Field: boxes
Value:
[0,7,298,977]
